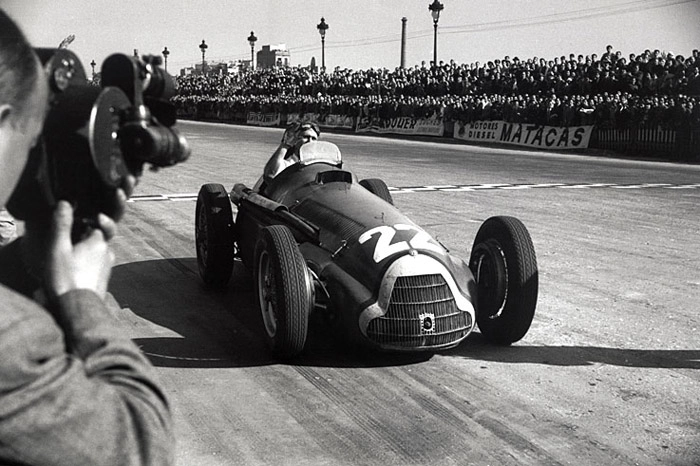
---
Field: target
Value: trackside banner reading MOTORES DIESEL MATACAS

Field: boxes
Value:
[454,121,593,150]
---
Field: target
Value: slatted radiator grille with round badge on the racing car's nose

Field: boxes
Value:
[367,274,472,349]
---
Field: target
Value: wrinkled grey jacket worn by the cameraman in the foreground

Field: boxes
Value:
[0,238,174,466]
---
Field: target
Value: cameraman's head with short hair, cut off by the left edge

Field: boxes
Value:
[0,9,49,206]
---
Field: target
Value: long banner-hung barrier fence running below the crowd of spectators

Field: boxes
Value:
[178,105,700,162]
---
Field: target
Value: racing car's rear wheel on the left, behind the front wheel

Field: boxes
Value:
[194,183,235,288]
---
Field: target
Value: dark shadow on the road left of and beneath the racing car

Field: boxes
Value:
[110,257,432,368]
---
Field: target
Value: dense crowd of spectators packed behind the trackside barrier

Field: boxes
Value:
[174,46,700,128]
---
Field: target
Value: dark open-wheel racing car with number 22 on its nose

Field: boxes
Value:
[195,141,538,358]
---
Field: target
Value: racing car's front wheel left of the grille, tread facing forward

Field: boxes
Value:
[254,225,314,359]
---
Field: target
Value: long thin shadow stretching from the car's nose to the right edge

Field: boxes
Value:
[444,332,700,369]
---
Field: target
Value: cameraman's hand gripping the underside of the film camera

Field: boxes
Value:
[45,201,116,298]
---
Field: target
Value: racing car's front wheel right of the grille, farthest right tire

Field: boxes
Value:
[469,217,538,345]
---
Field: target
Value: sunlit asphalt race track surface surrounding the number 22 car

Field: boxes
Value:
[111,122,700,466]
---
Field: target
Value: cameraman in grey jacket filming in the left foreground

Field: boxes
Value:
[0,9,174,466]
